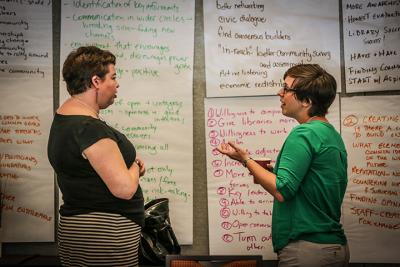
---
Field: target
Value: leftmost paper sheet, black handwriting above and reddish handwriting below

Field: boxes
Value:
[0,1,54,242]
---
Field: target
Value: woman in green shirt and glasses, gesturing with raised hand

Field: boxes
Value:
[217,64,349,267]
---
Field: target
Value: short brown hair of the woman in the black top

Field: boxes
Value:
[62,46,116,95]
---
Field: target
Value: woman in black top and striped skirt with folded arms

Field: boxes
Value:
[48,46,145,266]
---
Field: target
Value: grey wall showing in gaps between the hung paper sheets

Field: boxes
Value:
[3,0,400,266]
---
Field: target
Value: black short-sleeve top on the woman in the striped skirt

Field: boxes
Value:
[47,114,144,226]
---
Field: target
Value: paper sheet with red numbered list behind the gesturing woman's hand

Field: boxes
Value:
[205,97,339,260]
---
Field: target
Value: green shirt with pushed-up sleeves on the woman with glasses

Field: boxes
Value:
[272,120,347,252]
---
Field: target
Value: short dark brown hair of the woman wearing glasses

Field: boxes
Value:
[283,64,336,116]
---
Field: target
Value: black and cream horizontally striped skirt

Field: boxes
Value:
[58,212,141,266]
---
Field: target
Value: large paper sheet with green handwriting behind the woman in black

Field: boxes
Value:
[60,1,194,244]
